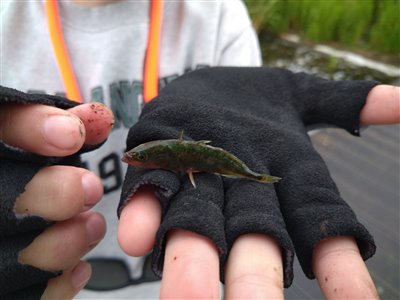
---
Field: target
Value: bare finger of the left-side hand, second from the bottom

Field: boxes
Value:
[18,212,106,271]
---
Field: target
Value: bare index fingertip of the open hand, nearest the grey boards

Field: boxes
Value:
[313,237,379,299]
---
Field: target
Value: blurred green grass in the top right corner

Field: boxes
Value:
[245,0,400,58]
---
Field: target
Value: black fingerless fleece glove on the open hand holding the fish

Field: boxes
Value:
[118,67,377,287]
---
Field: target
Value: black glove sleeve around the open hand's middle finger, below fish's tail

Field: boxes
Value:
[224,179,294,287]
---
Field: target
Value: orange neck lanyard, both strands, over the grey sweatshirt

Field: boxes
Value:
[45,0,163,103]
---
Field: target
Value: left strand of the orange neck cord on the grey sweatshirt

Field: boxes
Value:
[45,0,83,103]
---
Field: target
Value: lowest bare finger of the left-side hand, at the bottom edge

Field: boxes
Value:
[41,261,92,300]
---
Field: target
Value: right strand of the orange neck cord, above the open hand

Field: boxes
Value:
[143,0,163,103]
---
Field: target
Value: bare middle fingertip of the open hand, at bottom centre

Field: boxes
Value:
[225,233,283,299]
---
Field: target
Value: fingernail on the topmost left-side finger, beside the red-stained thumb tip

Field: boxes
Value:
[43,115,85,150]
